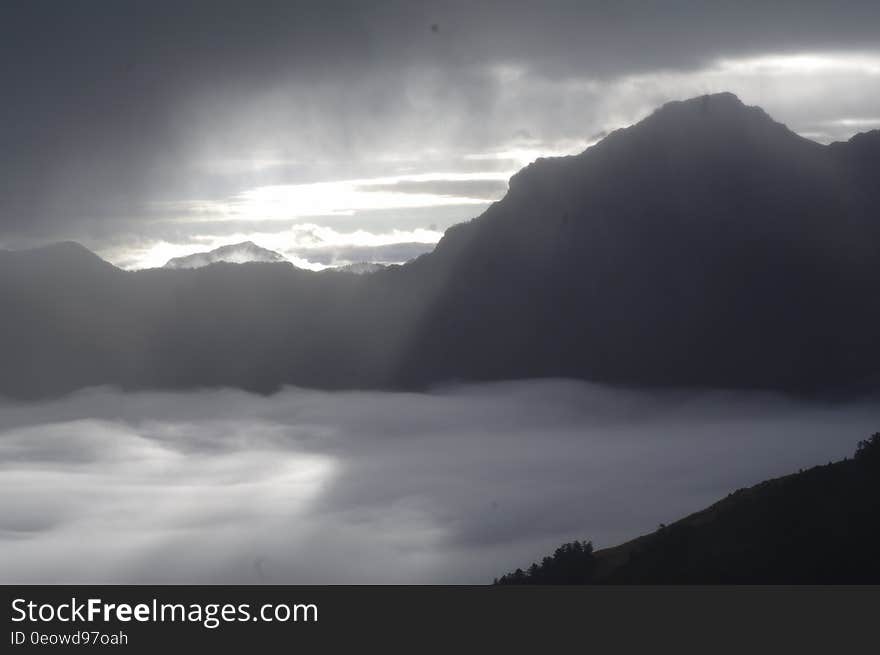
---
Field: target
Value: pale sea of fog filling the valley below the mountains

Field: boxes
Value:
[0,380,880,584]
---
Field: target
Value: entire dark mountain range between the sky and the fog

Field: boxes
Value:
[0,93,880,397]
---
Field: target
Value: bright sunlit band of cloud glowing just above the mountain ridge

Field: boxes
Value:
[99,51,880,269]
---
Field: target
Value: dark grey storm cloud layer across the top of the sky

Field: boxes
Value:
[0,0,880,246]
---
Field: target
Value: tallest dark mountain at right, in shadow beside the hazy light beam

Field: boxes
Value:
[392,94,880,389]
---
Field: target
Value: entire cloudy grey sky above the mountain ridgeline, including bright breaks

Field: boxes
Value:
[0,0,880,267]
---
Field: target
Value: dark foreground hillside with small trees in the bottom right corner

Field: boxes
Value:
[499,434,880,584]
